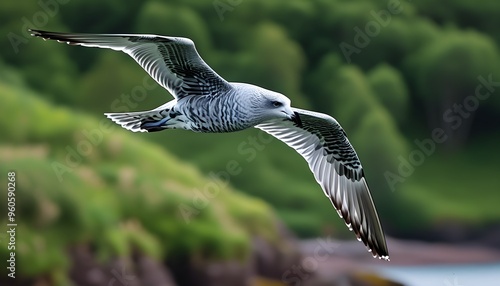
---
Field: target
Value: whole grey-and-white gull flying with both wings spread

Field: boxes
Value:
[29,29,389,260]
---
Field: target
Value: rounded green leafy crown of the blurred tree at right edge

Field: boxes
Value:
[408,28,499,102]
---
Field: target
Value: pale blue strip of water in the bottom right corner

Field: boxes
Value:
[376,263,500,286]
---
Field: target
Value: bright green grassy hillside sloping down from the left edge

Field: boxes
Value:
[0,69,282,282]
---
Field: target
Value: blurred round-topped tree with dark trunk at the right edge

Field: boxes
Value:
[406,30,500,150]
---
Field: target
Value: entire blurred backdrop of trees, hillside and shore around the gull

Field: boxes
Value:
[0,0,500,286]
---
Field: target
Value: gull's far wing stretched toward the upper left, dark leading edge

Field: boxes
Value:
[30,30,231,99]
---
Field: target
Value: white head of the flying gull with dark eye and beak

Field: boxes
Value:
[252,90,295,121]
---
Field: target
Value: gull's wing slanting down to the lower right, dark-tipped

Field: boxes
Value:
[256,108,389,260]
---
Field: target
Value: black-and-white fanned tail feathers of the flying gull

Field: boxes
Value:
[104,110,168,132]
